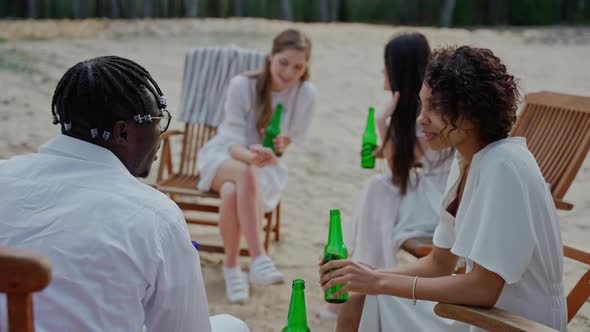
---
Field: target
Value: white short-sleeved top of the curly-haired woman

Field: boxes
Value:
[433,137,567,331]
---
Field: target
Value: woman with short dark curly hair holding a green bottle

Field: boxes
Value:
[320,46,567,331]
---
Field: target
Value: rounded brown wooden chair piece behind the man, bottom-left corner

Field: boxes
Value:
[0,248,51,332]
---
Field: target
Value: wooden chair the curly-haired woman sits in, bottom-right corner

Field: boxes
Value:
[434,246,590,332]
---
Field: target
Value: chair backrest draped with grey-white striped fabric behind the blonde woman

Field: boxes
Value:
[179,47,265,176]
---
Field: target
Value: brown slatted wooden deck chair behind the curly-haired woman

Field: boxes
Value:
[401,92,590,257]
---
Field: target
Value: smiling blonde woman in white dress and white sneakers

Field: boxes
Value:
[198,29,316,303]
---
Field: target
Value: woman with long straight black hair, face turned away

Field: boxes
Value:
[318,33,452,318]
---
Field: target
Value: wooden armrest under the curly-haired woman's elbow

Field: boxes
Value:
[434,303,556,332]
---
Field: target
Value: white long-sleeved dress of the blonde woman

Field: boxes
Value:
[197,75,316,211]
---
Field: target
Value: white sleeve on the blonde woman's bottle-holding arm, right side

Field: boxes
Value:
[290,82,317,145]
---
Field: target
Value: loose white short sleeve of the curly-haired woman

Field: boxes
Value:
[451,160,535,284]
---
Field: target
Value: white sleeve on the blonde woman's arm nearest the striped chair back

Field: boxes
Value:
[219,75,252,147]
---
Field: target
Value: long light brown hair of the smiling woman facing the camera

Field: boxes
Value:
[244,29,311,133]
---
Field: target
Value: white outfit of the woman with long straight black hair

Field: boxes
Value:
[343,149,453,268]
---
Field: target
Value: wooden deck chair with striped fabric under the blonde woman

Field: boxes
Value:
[155,47,281,256]
